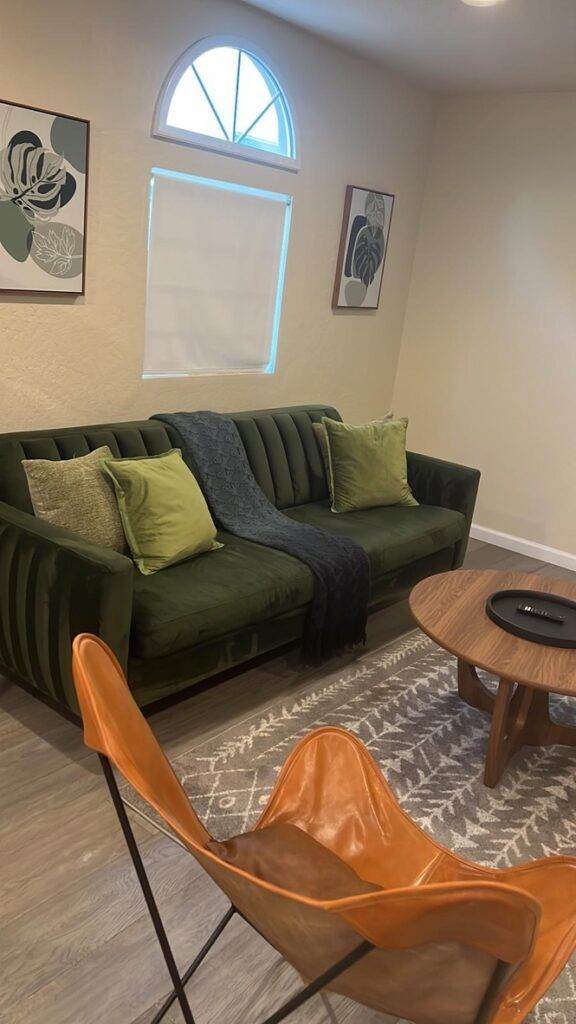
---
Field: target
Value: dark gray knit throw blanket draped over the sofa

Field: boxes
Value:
[153,413,370,659]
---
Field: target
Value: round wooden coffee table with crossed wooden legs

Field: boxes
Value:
[410,569,576,786]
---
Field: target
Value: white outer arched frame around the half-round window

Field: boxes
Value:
[152,36,300,171]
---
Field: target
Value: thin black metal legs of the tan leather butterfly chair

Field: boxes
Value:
[98,755,374,1024]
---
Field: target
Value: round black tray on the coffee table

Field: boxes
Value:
[486,590,576,647]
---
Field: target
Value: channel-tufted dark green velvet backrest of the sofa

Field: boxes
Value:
[0,406,340,512]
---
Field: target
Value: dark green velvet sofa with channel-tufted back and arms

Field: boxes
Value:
[0,406,480,717]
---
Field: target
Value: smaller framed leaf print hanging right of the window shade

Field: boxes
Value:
[332,185,394,309]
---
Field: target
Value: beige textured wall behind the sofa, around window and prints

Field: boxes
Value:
[0,0,431,430]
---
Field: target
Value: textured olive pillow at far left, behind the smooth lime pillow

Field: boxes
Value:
[22,444,126,551]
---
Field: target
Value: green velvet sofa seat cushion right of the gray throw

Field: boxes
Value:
[286,501,466,582]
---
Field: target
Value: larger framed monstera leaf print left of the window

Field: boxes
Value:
[0,100,89,295]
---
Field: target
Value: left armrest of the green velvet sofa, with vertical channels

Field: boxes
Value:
[0,502,133,715]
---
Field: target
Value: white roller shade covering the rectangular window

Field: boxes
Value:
[143,168,291,376]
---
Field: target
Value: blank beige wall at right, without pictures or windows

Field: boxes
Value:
[394,94,576,553]
